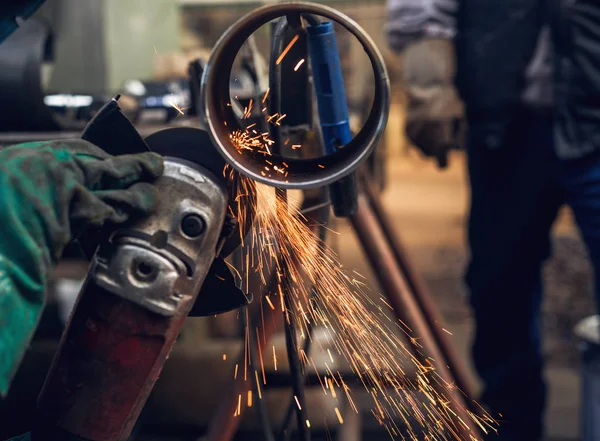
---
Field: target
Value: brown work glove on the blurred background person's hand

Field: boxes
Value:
[402,39,465,168]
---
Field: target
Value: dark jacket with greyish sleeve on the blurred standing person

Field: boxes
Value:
[386,0,600,159]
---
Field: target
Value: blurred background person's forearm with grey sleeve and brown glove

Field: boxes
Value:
[386,0,464,167]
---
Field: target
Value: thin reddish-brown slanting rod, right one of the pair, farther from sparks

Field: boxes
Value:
[361,178,475,396]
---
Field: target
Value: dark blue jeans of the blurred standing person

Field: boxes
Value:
[466,107,600,441]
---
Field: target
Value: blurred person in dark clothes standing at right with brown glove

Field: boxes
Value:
[387,0,600,441]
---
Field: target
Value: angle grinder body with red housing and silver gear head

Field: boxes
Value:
[38,159,228,441]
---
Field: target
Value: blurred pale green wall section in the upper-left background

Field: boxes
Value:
[39,0,181,94]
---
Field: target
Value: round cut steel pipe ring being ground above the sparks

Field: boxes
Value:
[201,3,390,189]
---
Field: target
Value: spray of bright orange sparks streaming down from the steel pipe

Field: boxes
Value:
[225,115,496,441]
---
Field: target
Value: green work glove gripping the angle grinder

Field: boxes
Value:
[0,140,163,396]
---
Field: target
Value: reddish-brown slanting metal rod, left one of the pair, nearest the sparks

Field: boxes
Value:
[351,194,478,440]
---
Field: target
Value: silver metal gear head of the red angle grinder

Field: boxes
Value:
[91,161,228,317]
